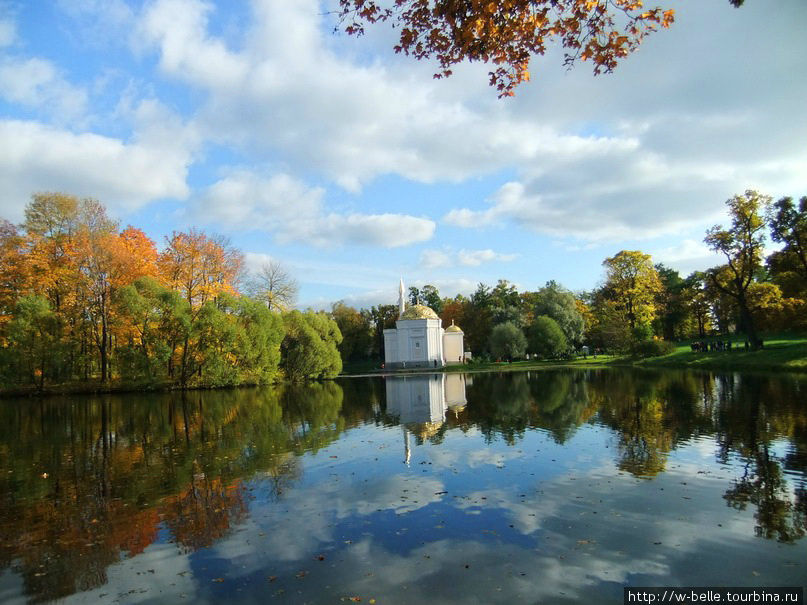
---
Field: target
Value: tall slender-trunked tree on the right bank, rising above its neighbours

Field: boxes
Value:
[704,190,771,349]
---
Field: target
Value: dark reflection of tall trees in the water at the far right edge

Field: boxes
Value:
[718,376,807,542]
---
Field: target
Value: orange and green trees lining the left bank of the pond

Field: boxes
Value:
[0,193,342,388]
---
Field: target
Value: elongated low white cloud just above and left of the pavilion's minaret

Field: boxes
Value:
[195,170,436,248]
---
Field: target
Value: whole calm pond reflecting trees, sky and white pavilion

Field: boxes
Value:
[0,369,807,604]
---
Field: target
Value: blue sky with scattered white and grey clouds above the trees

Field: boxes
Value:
[0,0,807,308]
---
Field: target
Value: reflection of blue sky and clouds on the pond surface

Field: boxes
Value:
[7,386,807,604]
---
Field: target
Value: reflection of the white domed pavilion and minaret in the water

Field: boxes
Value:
[386,374,470,464]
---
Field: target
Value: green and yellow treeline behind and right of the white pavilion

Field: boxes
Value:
[332,191,807,361]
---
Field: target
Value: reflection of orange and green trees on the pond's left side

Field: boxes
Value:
[0,383,343,602]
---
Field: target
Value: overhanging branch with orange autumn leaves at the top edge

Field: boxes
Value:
[339,0,680,97]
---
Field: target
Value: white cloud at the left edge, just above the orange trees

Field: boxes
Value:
[0,120,190,220]
